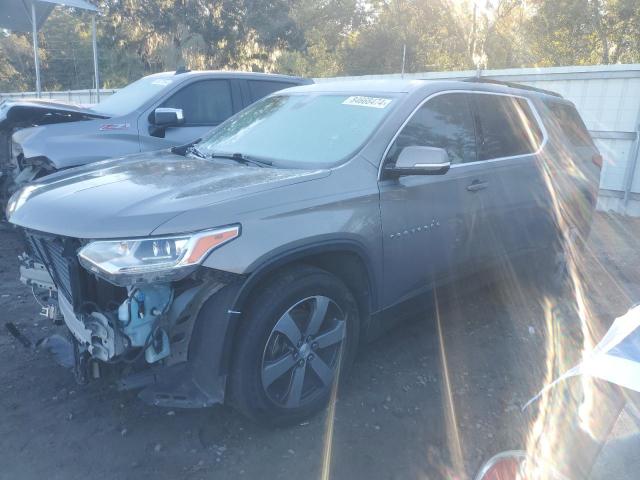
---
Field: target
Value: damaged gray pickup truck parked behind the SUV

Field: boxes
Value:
[0,71,311,210]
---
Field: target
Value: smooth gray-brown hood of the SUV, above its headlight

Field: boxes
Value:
[10,151,330,239]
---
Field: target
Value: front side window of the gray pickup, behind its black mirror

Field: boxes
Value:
[162,80,233,126]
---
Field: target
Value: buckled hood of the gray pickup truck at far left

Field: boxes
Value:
[0,100,108,130]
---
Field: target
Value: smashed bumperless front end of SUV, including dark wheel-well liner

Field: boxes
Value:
[23,234,243,408]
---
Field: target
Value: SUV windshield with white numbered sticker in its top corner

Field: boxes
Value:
[198,93,393,167]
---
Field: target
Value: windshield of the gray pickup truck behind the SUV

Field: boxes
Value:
[92,75,173,117]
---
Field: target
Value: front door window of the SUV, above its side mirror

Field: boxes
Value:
[389,93,476,163]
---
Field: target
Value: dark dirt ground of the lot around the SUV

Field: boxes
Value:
[0,215,640,479]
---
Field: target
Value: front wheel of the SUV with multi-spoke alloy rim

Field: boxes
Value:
[230,266,359,425]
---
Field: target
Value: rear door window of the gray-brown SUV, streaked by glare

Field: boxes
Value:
[473,94,542,160]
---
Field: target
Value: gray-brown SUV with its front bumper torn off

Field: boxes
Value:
[7,79,601,423]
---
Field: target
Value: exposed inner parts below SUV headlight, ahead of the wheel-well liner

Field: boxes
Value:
[20,232,239,406]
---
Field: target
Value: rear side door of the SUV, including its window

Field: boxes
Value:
[471,91,548,263]
